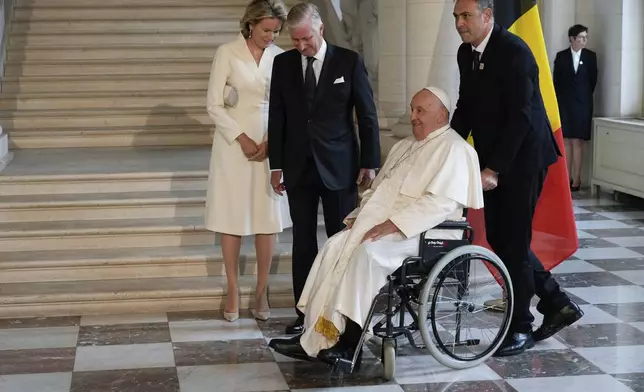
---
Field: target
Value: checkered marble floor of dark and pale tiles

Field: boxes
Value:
[0,189,644,392]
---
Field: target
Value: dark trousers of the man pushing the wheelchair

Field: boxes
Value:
[484,170,570,332]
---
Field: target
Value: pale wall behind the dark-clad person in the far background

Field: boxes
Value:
[538,0,644,184]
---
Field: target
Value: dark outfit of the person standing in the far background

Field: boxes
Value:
[553,48,598,139]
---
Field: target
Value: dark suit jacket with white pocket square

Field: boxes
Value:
[268,44,380,190]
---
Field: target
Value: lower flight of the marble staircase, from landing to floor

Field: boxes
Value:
[0,147,326,317]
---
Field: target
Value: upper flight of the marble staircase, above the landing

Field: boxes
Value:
[0,0,294,149]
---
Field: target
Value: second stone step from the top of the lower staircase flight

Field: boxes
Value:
[0,190,206,223]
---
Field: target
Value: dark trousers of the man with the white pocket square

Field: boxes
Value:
[286,158,358,316]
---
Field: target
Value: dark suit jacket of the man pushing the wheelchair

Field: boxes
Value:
[451,24,561,174]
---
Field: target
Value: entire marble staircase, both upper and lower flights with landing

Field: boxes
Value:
[0,0,316,317]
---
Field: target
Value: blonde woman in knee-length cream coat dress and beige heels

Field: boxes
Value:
[206,0,291,321]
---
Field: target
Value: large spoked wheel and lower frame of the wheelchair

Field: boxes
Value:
[368,245,513,369]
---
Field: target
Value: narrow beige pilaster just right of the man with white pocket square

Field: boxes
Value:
[374,0,407,128]
